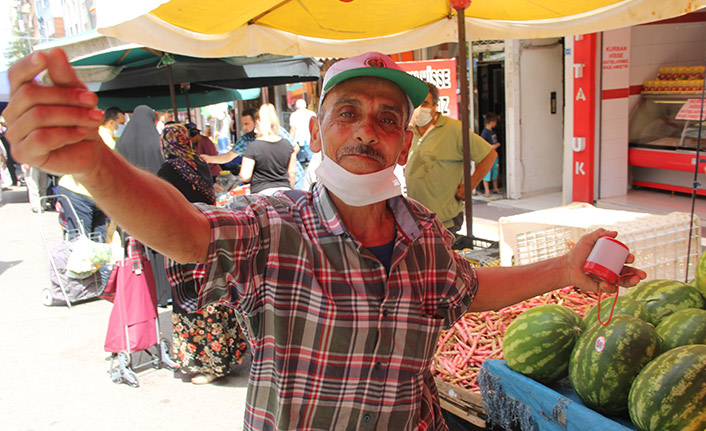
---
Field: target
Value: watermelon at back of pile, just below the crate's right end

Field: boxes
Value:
[625,280,706,325]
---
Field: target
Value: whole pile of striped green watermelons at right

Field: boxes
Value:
[503,260,706,431]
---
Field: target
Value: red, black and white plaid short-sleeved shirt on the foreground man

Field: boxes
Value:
[169,184,478,430]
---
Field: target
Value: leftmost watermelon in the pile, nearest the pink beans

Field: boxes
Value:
[503,304,583,383]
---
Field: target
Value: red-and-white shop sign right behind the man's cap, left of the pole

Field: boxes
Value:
[397,59,458,120]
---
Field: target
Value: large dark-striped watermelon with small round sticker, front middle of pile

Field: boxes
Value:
[569,314,662,415]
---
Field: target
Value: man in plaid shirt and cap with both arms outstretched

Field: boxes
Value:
[4,50,644,430]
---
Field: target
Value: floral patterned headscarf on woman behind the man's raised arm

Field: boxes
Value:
[161,123,216,204]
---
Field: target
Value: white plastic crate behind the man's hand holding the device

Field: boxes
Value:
[498,203,701,280]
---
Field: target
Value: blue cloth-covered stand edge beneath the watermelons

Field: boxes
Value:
[478,359,635,431]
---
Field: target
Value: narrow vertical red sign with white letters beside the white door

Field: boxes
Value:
[572,33,596,204]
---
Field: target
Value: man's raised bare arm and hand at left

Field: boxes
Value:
[3,49,210,262]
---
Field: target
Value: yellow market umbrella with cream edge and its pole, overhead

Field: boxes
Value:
[97,0,706,234]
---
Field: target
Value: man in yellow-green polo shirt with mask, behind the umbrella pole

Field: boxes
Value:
[404,82,498,235]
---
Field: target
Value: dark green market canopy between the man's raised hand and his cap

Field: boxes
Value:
[37,31,320,115]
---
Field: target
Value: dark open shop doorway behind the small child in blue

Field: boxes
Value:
[474,60,507,192]
